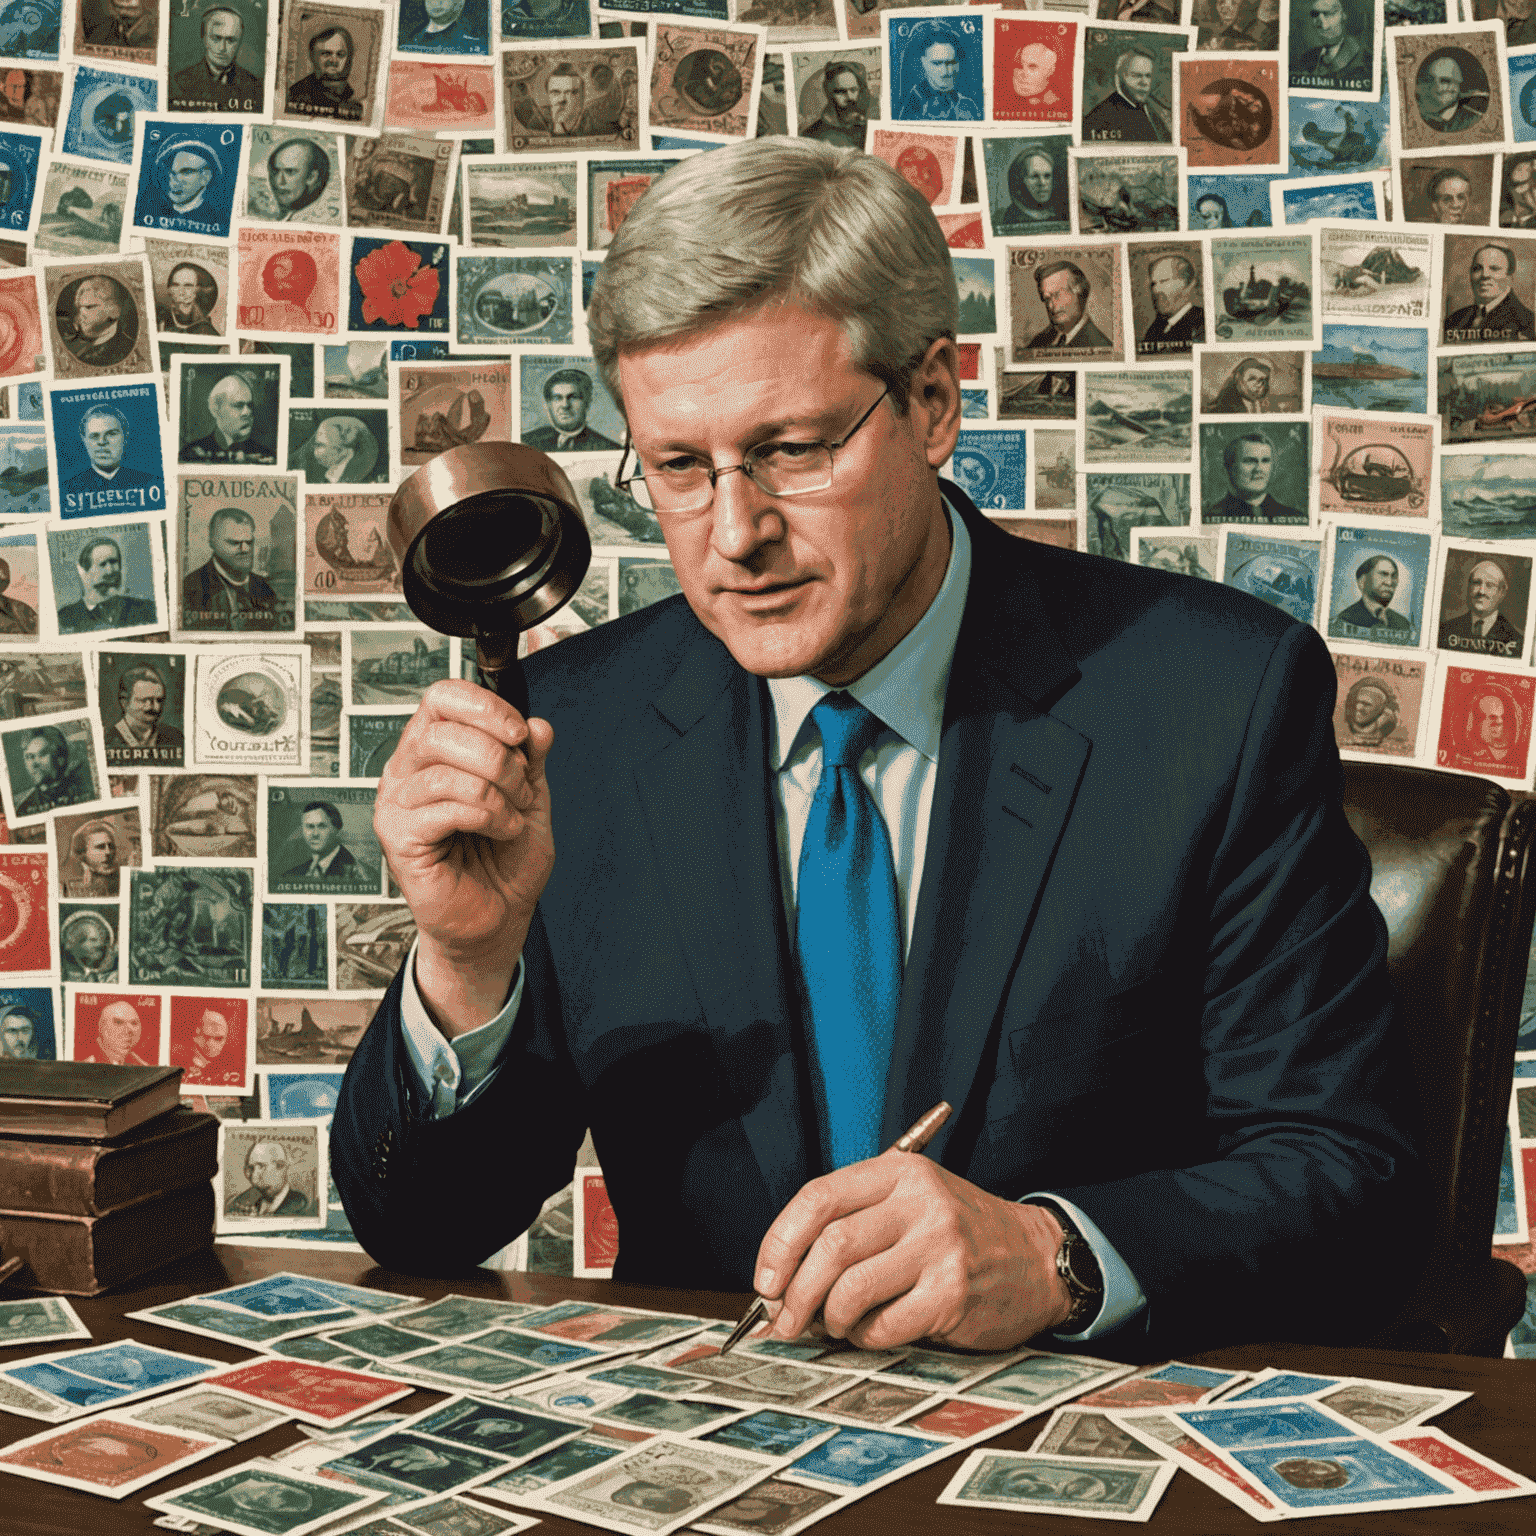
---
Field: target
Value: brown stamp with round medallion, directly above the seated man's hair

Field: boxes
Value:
[651,18,764,139]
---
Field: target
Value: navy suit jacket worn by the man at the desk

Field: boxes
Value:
[332,488,1421,1353]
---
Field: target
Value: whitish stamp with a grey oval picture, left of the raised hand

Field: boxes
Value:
[190,645,309,773]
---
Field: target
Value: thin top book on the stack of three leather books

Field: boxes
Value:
[0,1061,181,1141]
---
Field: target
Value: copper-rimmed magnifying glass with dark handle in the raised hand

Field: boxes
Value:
[387,442,591,717]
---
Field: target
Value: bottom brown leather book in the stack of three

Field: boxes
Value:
[0,1181,214,1296]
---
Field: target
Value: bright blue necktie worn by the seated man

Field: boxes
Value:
[796,693,902,1167]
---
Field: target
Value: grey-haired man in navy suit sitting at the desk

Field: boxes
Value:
[332,138,1421,1353]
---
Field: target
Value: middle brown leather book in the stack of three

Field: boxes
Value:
[0,1107,218,1217]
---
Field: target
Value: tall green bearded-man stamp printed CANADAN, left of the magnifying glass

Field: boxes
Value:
[172,470,298,636]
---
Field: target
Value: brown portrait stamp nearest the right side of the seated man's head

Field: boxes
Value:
[1008,241,1126,364]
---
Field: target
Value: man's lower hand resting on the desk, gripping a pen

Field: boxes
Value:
[756,1150,1072,1350]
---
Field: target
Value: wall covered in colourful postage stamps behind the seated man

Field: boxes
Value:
[0,0,1536,1347]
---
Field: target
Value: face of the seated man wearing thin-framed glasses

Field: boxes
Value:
[619,304,958,687]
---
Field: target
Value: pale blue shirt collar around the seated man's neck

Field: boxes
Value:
[768,488,971,773]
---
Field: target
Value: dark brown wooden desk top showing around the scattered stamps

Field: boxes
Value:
[0,1246,1536,1536]
